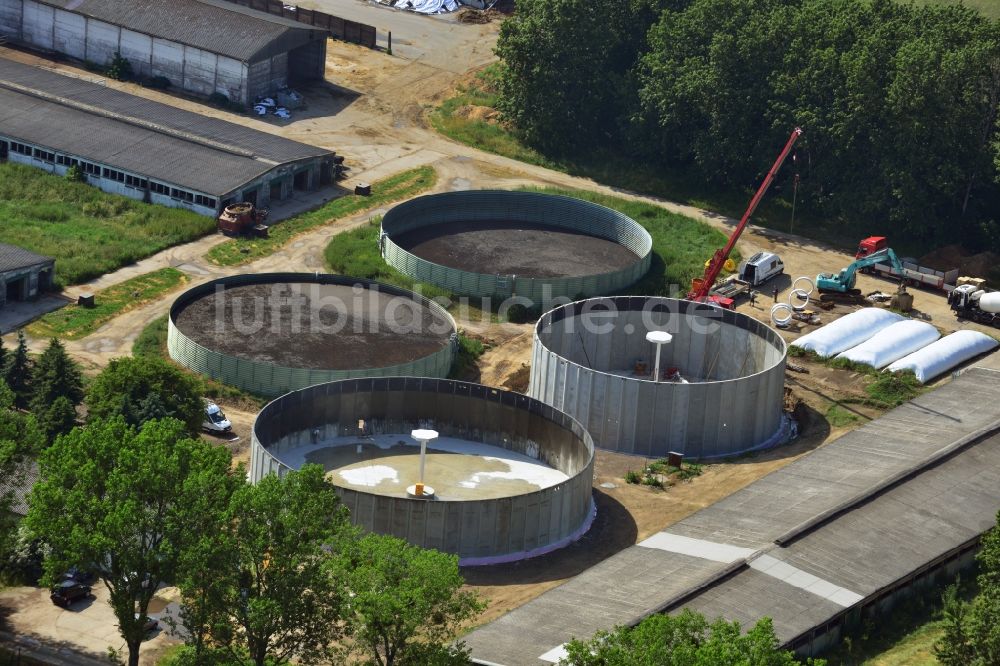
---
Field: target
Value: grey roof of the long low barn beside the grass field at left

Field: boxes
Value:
[0,58,333,196]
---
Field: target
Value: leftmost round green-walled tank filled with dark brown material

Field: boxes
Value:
[167,273,457,396]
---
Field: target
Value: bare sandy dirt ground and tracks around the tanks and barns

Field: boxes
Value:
[0,14,1000,663]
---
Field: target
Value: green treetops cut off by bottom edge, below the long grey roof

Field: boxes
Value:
[559,610,825,666]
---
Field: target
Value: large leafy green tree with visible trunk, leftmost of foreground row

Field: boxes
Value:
[26,417,239,666]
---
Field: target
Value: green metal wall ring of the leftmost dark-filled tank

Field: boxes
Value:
[167,273,458,396]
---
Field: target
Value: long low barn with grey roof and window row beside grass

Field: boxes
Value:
[0,58,334,215]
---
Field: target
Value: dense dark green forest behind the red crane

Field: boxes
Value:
[497,0,1000,250]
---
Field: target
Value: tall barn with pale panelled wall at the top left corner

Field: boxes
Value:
[0,0,327,105]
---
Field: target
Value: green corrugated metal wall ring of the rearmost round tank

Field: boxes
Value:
[379,190,653,304]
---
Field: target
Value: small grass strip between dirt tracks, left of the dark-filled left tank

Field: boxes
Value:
[27,268,188,340]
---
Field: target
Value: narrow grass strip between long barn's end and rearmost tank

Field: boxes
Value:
[205,166,437,266]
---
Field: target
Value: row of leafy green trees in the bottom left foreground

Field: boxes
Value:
[25,416,482,666]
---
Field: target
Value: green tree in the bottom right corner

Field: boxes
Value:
[934,513,1000,666]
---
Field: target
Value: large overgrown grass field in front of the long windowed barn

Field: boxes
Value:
[0,163,215,286]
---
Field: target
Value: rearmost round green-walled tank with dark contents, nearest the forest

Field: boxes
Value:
[379,190,653,305]
